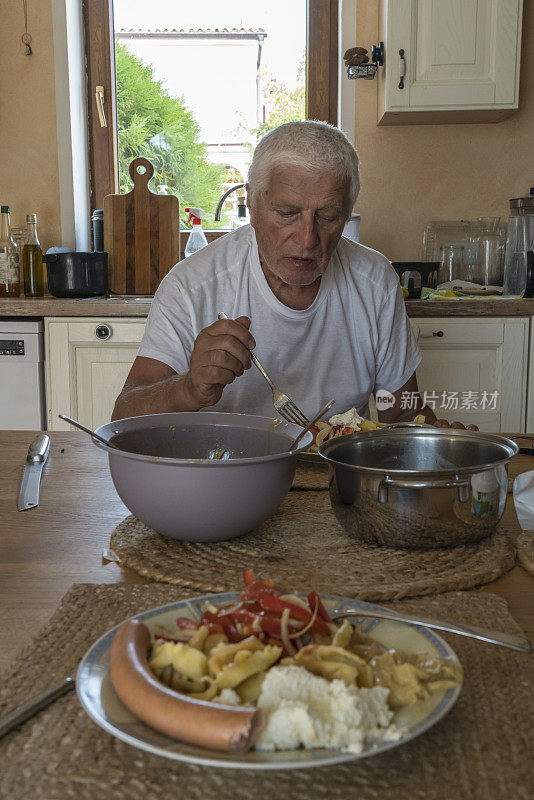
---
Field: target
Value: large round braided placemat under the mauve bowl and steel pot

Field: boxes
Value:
[110,491,515,601]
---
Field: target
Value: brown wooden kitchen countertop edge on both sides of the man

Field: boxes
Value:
[0,296,534,317]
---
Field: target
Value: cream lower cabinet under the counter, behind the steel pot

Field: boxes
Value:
[410,317,530,433]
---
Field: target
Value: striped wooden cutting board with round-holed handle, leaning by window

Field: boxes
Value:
[104,158,180,294]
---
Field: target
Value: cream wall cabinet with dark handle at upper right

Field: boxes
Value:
[378,0,523,125]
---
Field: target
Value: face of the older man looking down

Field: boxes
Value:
[249,167,350,286]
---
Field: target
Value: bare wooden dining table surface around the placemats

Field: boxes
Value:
[0,431,534,670]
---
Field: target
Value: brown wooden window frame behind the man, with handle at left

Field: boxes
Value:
[82,0,339,216]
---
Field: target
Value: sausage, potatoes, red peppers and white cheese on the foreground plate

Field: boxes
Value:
[110,570,461,753]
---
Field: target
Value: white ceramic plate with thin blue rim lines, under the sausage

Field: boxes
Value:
[76,593,461,769]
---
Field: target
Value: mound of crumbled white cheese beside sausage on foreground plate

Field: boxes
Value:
[255,666,401,753]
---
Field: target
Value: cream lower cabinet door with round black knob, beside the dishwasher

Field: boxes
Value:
[45,317,146,430]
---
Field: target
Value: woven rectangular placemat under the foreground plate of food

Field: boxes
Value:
[0,584,534,800]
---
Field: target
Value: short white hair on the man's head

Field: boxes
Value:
[247,120,360,210]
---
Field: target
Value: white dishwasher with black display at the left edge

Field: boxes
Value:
[0,318,46,430]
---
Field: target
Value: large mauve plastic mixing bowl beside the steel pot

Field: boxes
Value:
[93,411,313,542]
